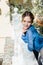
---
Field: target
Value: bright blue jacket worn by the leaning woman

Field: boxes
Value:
[21,25,43,52]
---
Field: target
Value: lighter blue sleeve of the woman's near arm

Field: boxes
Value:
[28,30,34,51]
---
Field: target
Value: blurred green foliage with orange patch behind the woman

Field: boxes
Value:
[9,0,43,35]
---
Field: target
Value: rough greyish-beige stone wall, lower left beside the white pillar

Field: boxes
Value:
[2,37,14,65]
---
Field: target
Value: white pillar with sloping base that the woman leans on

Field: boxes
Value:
[12,8,38,65]
